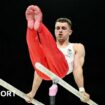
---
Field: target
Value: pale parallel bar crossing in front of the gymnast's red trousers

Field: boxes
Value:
[35,63,98,105]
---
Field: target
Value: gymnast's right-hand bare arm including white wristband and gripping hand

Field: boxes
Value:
[73,44,90,102]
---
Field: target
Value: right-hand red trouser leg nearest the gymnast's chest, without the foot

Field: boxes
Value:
[38,23,68,78]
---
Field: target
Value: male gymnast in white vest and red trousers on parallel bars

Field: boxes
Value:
[25,5,90,103]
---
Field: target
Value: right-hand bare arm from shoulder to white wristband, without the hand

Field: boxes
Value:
[73,44,85,88]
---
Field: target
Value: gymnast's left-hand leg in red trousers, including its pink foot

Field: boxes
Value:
[26,5,48,78]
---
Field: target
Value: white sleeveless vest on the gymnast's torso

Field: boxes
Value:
[58,43,75,74]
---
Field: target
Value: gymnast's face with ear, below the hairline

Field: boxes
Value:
[55,22,72,42]
